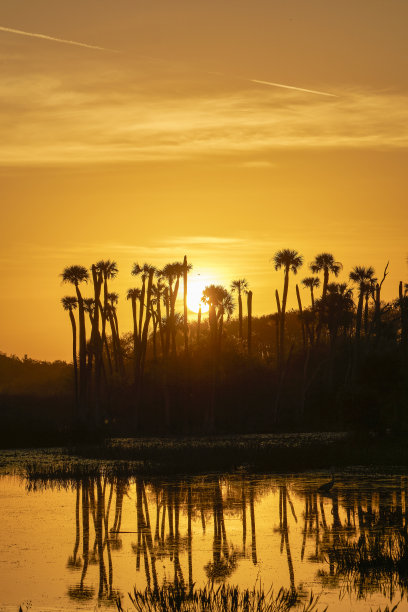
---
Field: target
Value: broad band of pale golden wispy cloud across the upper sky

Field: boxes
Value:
[0,75,408,165]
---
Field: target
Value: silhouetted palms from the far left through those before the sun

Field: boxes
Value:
[61,256,252,421]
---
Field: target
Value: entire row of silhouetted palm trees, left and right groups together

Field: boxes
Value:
[61,249,408,427]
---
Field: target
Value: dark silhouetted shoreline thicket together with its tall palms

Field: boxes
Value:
[0,249,408,450]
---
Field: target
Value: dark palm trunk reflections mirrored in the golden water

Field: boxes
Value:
[20,474,408,601]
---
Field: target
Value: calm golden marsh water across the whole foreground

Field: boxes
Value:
[0,470,408,612]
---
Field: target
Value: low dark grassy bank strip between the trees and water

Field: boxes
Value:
[0,432,408,478]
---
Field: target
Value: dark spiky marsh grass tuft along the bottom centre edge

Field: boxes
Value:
[117,584,327,612]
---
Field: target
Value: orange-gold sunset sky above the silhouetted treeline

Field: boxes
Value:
[0,0,408,359]
